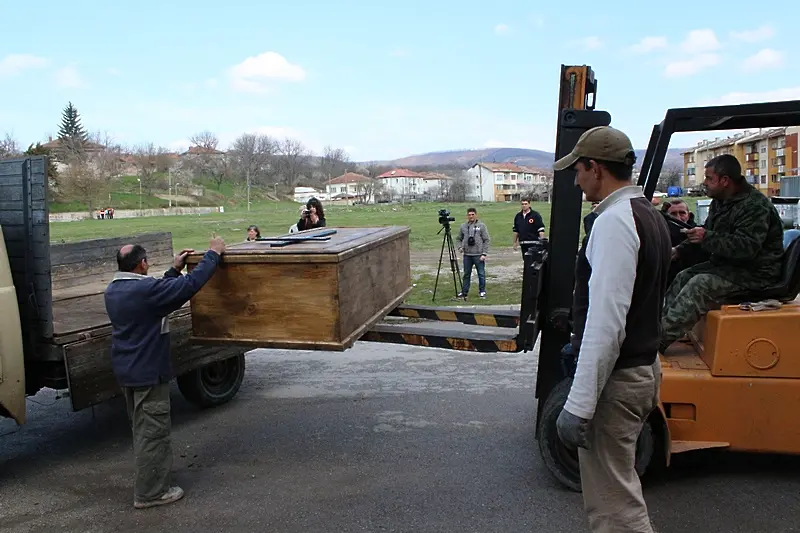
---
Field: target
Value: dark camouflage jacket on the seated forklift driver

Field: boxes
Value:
[677,184,783,289]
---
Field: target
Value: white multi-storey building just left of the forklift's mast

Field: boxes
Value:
[465,163,552,202]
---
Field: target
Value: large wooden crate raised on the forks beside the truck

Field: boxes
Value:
[187,226,411,350]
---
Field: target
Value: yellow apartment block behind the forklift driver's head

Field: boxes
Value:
[683,127,800,196]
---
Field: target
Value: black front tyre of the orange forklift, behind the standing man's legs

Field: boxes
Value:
[538,379,660,492]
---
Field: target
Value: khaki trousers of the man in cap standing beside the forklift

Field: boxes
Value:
[578,359,661,533]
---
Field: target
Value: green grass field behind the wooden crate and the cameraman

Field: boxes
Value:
[50,198,696,305]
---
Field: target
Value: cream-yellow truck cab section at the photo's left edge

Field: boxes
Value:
[0,227,25,424]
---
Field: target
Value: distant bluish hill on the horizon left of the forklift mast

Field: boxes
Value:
[370,148,685,169]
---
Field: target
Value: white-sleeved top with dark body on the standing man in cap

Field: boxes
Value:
[564,185,671,419]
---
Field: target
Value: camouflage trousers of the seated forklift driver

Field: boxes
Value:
[660,268,744,353]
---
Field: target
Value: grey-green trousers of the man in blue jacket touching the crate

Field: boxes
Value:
[123,383,172,502]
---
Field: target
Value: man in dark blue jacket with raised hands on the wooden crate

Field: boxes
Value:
[105,237,225,509]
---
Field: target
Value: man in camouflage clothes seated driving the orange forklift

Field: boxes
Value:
[659,154,783,353]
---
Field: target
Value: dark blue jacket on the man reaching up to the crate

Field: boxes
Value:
[105,250,220,387]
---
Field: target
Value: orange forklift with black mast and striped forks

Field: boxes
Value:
[362,65,800,491]
